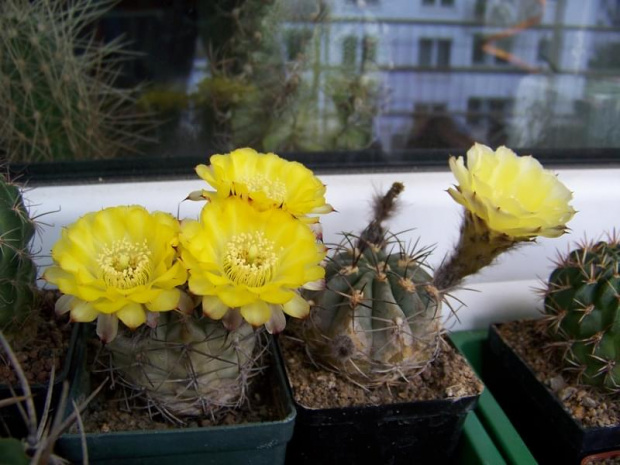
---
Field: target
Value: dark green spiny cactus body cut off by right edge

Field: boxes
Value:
[545,240,620,391]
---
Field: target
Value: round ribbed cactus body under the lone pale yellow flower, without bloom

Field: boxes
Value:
[304,242,442,385]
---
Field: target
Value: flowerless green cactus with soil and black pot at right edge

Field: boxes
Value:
[489,236,620,464]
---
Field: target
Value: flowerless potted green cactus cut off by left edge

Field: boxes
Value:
[0,175,78,437]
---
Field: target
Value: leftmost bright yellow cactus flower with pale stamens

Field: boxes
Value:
[44,206,187,342]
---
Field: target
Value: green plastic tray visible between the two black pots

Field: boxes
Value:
[450,329,537,465]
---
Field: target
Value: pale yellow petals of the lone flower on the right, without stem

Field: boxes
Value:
[448,144,575,239]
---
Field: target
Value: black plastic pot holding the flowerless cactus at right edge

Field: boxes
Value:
[483,325,620,465]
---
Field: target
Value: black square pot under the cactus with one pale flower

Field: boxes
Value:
[278,338,479,465]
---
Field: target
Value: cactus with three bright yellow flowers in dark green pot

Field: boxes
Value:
[44,149,331,464]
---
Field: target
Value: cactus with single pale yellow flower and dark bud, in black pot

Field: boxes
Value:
[282,144,574,463]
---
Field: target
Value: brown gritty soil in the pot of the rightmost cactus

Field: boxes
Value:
[498,320,620,428]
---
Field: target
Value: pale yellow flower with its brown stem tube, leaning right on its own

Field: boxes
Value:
[434,144,575,292]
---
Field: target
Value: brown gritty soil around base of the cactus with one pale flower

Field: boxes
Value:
[280,336,483,408]
